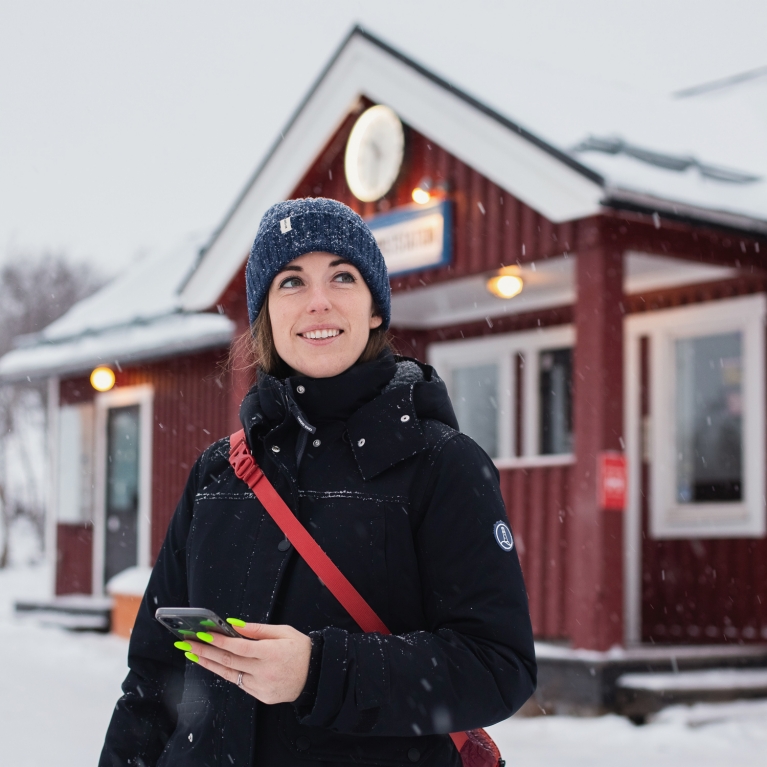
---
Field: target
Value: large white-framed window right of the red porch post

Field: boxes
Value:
[626,295,767,538]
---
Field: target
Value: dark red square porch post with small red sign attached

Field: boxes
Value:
[567,238,624,650]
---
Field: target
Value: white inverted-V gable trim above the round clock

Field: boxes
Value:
[181,33,603,311]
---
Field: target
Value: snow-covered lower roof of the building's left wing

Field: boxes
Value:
[0,235,234,381]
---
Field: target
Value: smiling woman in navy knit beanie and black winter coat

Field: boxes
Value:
[101,199,536,767]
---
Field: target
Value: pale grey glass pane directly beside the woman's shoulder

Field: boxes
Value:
[452,364,498,458]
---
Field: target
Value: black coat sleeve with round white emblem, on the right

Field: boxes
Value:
[301,434,537,736]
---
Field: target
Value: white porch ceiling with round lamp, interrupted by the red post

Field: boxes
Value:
[392,251,737,329]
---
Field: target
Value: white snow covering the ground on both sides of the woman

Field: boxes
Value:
[0,564,767,767]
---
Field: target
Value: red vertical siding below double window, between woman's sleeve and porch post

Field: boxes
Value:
[501,465,573,639]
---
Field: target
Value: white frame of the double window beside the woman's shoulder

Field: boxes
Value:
[426,325,575,469]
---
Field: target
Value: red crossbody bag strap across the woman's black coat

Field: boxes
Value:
[229,429,468,752]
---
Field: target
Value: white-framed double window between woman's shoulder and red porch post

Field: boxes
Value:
[429,326,575,463]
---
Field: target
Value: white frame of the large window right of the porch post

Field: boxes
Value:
[626,294,767,539]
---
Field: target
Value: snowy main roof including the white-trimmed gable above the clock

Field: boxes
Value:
[182,28,767,316]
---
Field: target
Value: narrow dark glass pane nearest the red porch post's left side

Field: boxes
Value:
[538,349,573,455]
